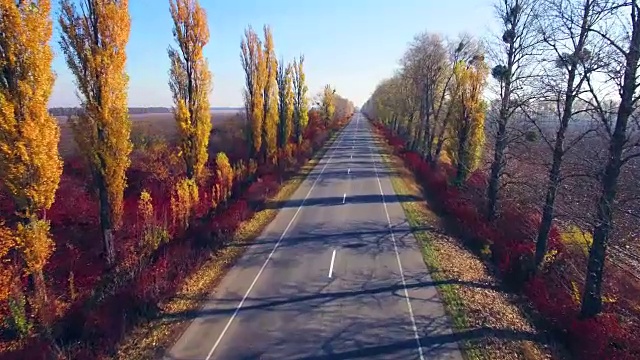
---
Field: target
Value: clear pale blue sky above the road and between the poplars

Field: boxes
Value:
[49,0,497,106]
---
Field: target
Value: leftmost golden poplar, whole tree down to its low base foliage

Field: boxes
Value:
[0,0,62,311]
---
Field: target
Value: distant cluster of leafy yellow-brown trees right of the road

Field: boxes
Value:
[363,33,489,183]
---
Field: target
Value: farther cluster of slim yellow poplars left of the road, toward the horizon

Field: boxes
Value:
[240,25,342,163]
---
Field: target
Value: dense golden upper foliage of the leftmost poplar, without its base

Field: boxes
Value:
[0,0,62,216]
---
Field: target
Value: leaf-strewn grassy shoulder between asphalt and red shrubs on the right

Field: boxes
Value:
[379,135,557,360]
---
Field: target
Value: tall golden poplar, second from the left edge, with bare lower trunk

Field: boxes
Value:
[59,0,132,265]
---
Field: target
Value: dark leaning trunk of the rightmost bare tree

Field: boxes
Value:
[580,19,640,318]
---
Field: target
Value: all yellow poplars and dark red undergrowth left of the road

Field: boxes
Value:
[0,0,354,359]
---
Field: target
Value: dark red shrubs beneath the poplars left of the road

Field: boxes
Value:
[0,112,350,359]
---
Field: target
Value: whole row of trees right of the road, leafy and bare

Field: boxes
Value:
[363,0,640,317]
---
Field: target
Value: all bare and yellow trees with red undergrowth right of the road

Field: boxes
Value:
[363,0,640,359]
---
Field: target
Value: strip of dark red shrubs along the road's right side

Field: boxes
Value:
[374,122,640,360]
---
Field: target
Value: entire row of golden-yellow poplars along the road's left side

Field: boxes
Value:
[0,0,352,332]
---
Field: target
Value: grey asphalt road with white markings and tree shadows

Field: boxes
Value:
[164,113,462,360]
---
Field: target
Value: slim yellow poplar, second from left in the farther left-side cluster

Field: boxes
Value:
[262,25,278,162]
